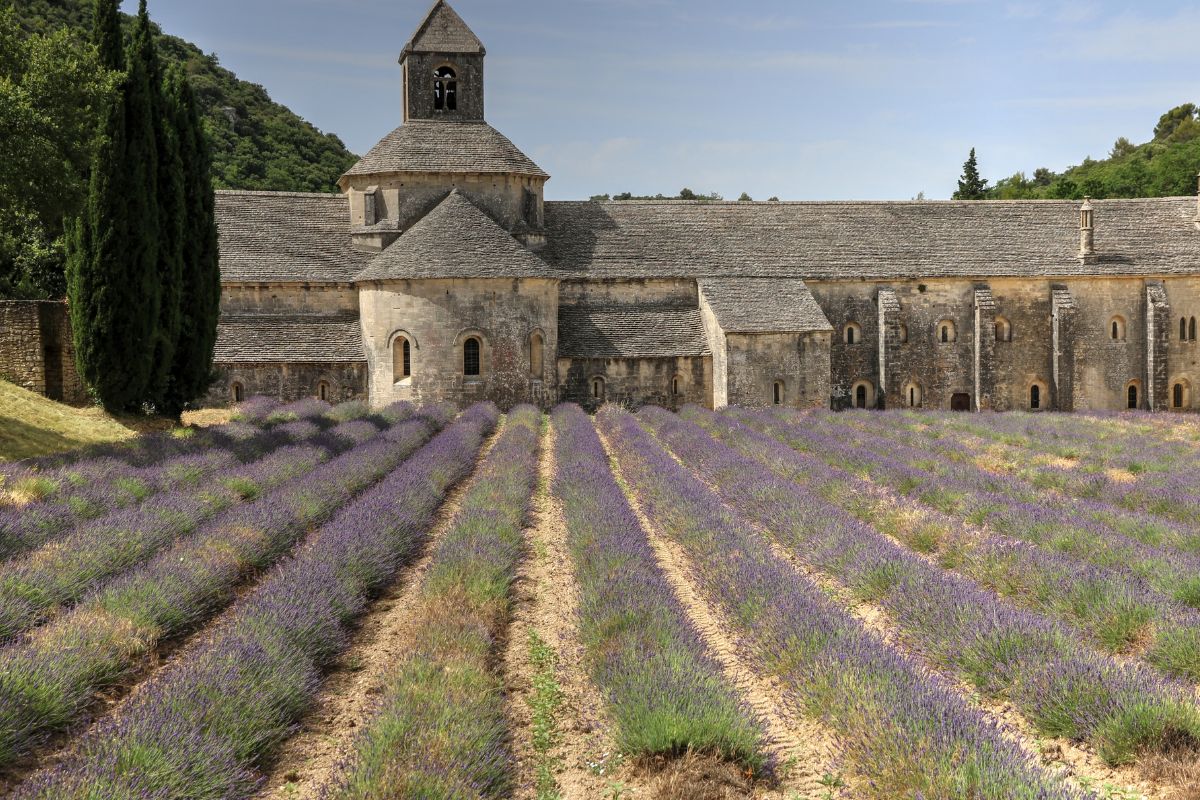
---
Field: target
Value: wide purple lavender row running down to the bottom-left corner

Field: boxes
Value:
[13,405,498,800]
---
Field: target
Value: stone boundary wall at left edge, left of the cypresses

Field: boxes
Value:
[0,301,88,403]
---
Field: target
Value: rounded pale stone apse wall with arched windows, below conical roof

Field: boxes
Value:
[360,278,558,408]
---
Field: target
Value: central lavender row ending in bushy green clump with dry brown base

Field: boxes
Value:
[552,405,764,770]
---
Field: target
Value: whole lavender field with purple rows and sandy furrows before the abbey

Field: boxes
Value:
[0,398,1200,800]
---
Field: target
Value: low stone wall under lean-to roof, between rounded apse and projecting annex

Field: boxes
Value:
[558,356,713,411]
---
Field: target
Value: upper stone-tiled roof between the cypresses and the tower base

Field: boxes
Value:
[216,191,370,283]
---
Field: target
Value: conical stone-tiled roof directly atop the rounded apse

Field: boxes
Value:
[356,190,551,281]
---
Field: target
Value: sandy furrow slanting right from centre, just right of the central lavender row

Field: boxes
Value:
[600,435,838,799]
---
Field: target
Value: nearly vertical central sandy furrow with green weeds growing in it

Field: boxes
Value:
[503,426,650,800]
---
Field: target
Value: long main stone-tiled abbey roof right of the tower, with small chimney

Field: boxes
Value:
[540,197,1200,283]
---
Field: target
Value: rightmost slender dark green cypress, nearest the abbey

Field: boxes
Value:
[163,66,221,416]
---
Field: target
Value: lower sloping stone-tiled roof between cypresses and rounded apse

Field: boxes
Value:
[212,314,367,363]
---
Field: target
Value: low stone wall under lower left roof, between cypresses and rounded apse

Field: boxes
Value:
[203,363,368,408]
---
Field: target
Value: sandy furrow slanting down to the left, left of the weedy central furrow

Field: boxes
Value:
[254,417,505,800]
